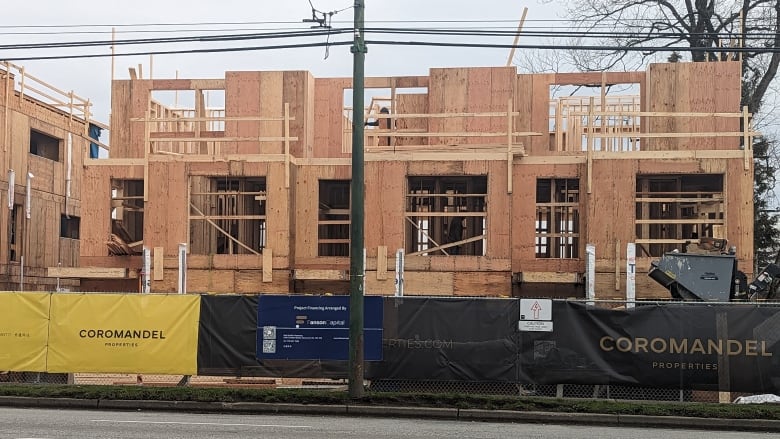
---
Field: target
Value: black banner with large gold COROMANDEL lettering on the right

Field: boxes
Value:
[520,302,780,393]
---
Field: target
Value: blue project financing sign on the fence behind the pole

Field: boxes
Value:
[256,295,382,361]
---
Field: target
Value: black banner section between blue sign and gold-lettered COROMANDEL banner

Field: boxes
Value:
[367,297,519,382]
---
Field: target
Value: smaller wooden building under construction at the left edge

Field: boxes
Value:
[0,62,108,291]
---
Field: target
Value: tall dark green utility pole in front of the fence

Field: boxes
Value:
[349,0,367,398]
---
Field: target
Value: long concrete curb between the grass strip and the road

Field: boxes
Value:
[0,396,780,432]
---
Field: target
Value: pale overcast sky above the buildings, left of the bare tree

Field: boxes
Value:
[0,0,557,121]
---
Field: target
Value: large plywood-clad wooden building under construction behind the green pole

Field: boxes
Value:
[65,62,754,298]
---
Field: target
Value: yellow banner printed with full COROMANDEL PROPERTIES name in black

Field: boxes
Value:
[48,294,200,375]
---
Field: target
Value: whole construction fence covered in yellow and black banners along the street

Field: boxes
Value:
[0,293,780,402]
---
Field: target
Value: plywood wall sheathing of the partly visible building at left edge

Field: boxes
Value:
[0,68,88,290]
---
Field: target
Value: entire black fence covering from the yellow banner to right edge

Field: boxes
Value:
[198,295,780,393]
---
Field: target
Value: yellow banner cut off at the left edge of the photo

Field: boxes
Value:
[0,292,49,372]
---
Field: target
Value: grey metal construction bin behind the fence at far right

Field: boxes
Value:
[648,238,780,302]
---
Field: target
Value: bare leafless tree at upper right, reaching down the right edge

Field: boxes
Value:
[523,0,780,265]
